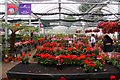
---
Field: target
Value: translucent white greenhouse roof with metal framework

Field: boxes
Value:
[0,0,119,27]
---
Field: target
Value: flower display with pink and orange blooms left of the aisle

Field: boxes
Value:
[2,40,34,63]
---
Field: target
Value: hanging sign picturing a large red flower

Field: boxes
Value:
[7,4,19,15]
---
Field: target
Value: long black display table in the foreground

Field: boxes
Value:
[7,63,120,80]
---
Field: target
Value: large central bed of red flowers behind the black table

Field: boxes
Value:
[36,40,120,71]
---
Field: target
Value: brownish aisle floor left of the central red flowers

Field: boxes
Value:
[2,49,36,78]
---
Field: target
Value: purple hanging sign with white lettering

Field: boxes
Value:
[19,4,31,15]
